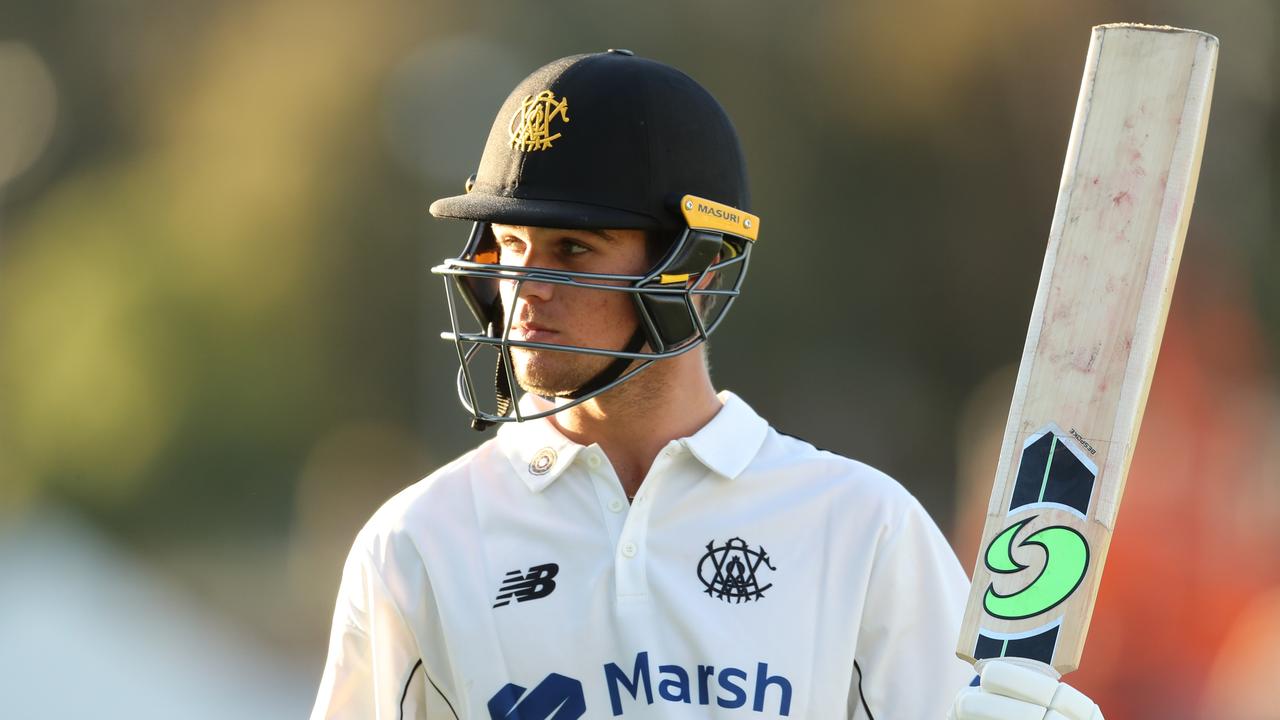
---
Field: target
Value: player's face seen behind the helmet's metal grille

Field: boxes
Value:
[493,224,648,396]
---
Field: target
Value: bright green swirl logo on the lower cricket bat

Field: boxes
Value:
[982,515,1089,620]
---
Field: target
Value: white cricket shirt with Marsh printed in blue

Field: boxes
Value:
[312,392,973,720]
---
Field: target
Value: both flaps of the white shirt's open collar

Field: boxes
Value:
[497,391,769,492]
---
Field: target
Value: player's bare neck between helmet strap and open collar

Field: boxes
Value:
[552,351,722,496]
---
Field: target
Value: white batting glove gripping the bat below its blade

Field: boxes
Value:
[948,660,1102,720]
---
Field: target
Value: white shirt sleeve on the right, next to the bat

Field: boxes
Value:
[849,498,974,720]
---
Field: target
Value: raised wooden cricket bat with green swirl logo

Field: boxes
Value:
[956,24,1219,676]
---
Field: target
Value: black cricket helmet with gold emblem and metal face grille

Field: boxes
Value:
[431,50,759,428]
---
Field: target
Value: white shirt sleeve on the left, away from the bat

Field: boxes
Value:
[311,541,440,720]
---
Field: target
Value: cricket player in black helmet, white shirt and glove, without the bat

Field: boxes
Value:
[312,50,1102,720]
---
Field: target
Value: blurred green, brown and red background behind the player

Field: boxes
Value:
[0,0,1280,720]
